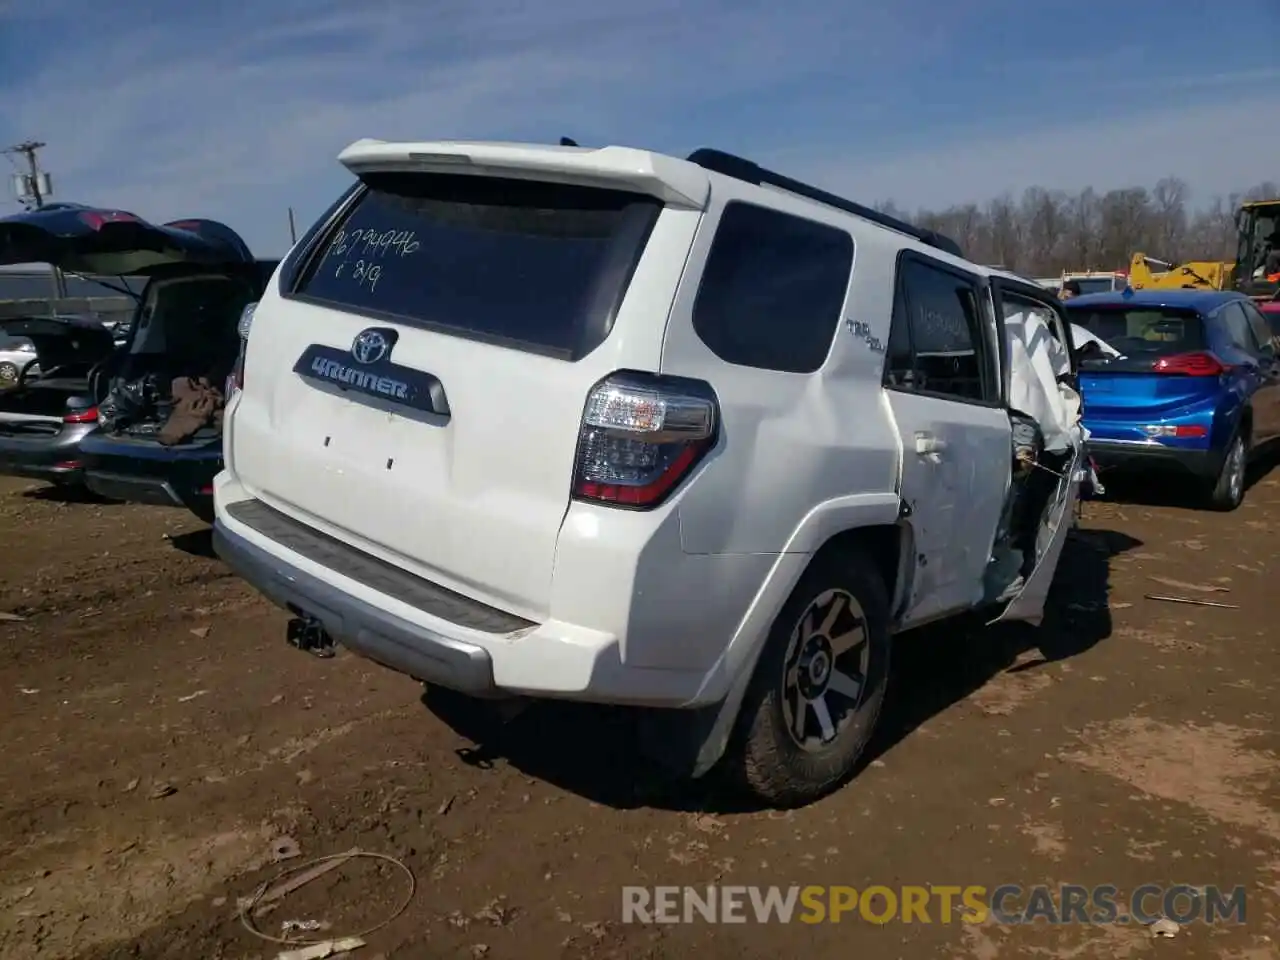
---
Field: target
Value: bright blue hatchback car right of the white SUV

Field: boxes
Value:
[1065,289,1280,511]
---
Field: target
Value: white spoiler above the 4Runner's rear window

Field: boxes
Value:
[338,140,710,210]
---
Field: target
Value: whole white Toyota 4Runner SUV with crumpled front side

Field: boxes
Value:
[215,140,1084,805]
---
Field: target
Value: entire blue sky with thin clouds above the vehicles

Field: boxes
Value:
[0,0,1280,256]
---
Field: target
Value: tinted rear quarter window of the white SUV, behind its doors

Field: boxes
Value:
[694,201,854,374]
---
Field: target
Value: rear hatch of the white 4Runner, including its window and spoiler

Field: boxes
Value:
[228,143,709,620]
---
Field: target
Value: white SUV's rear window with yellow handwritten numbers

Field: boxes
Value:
[296,173,660,360]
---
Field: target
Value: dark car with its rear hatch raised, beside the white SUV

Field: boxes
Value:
[0,204,259,512]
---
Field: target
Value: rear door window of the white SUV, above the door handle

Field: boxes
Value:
[884,257,998,401]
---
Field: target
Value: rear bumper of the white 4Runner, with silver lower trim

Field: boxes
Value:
[214,472,716,708]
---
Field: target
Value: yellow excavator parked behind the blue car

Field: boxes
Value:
[1129,200,1280,302]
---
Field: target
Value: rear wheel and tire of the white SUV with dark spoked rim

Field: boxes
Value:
[726,552,890,808]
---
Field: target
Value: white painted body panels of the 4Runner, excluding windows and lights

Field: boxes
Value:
[215,141,1074,707]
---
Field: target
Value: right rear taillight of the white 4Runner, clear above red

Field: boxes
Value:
[573,374,717,509]
